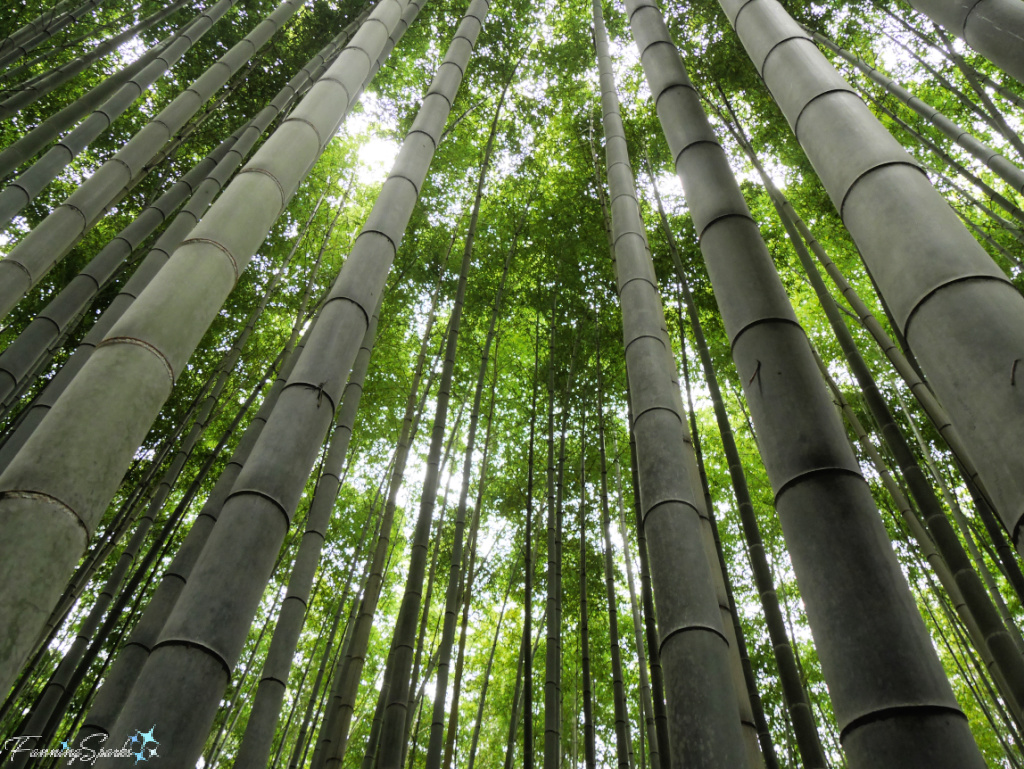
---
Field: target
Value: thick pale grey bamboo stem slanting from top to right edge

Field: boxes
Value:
[723,0,1024,540]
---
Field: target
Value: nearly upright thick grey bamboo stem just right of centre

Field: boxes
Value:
[594,0,748,768]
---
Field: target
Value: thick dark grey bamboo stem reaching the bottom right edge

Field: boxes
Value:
[631,0,991,767]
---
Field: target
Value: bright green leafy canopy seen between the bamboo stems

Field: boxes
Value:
[0,0,1024,767]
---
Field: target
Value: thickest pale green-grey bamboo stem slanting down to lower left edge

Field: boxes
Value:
[0,0,419,696]
